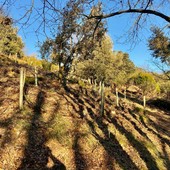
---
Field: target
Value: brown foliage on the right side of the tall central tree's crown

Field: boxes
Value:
[76,3,106,60]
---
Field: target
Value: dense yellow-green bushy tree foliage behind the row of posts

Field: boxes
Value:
[74,35,135,85]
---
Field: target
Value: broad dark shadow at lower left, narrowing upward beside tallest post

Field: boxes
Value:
[18,91,66,170]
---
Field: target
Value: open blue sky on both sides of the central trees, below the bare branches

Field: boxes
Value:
[6,1,169,71]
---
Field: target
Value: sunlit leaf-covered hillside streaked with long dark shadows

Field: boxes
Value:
[0,57,170,170]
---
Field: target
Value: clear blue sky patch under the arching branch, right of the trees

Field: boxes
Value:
[107,14,167,71]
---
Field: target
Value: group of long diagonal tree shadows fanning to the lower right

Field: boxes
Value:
[63,87,169,170]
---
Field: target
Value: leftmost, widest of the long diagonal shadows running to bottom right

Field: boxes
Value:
[66,87,138,170]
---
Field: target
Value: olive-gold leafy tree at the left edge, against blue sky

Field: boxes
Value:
[0,14,24,57]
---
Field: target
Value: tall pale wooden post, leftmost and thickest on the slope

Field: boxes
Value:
[19,67,25,109]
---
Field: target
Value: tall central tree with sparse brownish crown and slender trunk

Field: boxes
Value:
[40,0,106,85]
